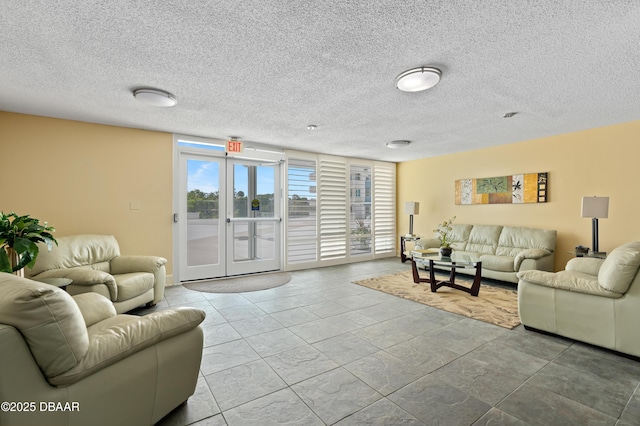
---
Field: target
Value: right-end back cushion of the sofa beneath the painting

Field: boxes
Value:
[496,226,557,257]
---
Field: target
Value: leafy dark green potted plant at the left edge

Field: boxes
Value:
[0,212,58,275]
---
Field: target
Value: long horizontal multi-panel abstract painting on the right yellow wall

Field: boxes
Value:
[456,172,549,204]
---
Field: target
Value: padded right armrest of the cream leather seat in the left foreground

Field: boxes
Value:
[48,308,206,386]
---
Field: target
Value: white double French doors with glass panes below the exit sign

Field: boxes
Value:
[175,152,282,281]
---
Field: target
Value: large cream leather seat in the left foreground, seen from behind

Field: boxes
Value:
[0,272,205,426]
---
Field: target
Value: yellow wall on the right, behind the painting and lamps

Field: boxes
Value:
[397,121,640,270]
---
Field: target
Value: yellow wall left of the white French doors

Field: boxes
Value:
[0,112,173,282]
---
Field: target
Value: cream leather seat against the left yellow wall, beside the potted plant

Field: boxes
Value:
[25,235,167,313]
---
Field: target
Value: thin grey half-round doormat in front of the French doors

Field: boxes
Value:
[182,272,291,293]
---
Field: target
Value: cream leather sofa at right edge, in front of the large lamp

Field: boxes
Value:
[518,241,640,357]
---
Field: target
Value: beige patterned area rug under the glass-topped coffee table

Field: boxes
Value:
[354,271,520,329]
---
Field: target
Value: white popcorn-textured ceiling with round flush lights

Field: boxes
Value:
[0,0,640,161]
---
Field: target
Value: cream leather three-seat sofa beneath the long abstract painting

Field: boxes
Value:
[416,224,557,283]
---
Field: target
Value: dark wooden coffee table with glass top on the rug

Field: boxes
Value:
[411,253,482,296]
